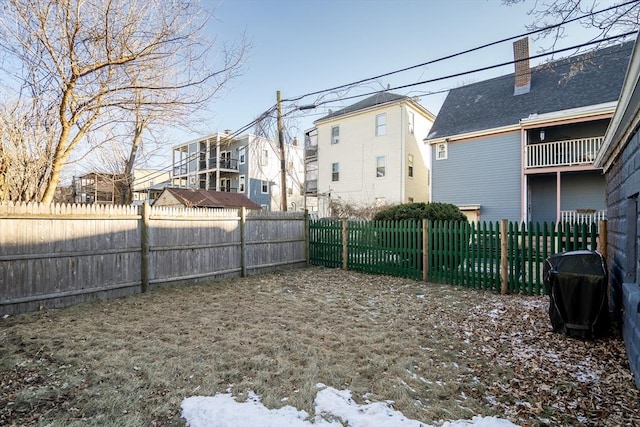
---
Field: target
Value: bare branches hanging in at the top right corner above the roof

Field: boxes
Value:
[502,0,640,50]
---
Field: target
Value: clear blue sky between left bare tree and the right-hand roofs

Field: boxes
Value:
[172,0,613,145]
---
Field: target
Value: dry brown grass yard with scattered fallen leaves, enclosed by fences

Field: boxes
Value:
[0,267,640,426]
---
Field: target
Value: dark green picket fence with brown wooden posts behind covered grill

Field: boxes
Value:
[309,220,598,295]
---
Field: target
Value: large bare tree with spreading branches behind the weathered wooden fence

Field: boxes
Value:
[0,0,247,203]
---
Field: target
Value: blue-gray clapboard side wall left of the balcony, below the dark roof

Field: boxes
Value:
[431,132,521,221]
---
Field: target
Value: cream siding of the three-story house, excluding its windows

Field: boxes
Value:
[316,98,432,216]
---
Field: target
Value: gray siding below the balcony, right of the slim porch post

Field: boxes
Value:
[560,171,606,211]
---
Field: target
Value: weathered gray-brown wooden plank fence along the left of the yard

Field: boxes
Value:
[0,203,307,315]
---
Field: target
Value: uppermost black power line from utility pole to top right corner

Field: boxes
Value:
[282,0,640,102]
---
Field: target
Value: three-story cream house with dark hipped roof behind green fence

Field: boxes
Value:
[305,92,435,217]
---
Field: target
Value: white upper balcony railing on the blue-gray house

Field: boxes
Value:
[525,136,604,168]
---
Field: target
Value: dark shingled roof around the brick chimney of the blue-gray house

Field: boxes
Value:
[427,42,633,139]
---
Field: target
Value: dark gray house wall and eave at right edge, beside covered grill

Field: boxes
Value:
[595,41,640,388]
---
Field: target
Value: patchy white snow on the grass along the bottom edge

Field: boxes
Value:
[182,384,515,427]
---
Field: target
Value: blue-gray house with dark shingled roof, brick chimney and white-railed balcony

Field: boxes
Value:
[425,38,633,222]
